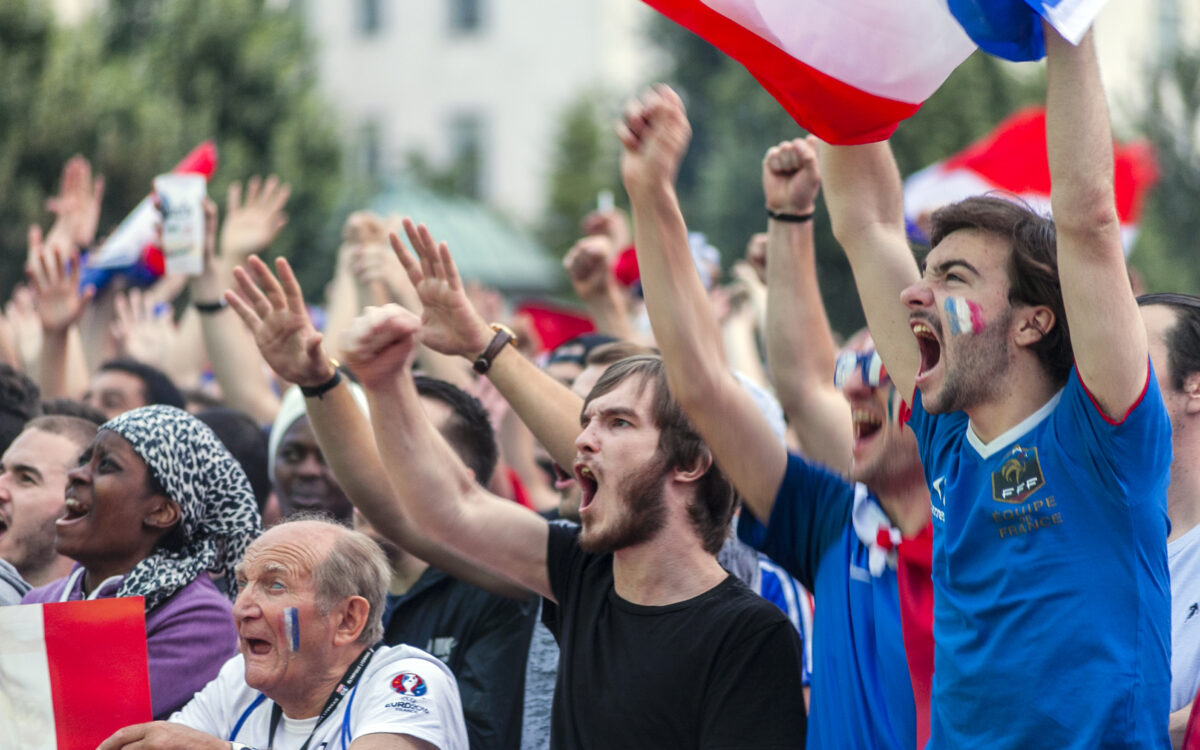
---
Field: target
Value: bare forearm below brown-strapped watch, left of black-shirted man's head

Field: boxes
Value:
[487,347,583,469]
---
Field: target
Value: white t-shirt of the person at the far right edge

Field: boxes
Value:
[1166,526,1200,712]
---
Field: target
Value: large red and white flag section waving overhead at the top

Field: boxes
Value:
[644,0,974,144]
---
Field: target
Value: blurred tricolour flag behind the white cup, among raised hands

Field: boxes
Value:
[80,140,217,290]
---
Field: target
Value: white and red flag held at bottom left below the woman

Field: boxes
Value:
[0,596,152,750]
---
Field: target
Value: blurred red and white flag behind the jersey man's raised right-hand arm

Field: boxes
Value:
[904,107,1158,254]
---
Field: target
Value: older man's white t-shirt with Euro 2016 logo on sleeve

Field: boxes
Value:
[170,646,468,750]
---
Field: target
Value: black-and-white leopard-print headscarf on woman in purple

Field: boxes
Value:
[100,404,263,611]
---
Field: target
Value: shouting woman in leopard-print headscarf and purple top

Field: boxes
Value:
[23,406,262,719]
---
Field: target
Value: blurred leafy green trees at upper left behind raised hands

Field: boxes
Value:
[0,0,344,298]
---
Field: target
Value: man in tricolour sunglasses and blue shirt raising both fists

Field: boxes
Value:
[625,88,929,749]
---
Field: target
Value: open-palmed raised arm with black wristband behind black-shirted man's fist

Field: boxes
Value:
[228,257,529,599]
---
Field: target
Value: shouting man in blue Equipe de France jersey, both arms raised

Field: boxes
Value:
[818,17,1171,750]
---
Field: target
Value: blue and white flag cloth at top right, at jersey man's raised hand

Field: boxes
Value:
[947,0,1108,61]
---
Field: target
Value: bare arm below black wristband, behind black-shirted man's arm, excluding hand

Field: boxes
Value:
[305,388,529,599]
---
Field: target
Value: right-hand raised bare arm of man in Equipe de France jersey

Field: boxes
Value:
[1044,24,1148,412]
